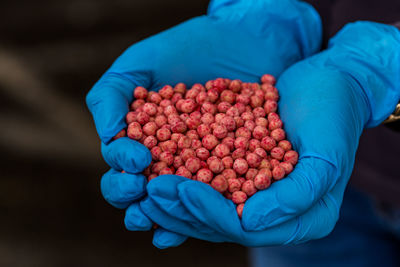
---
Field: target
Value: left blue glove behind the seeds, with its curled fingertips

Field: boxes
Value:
[86,0,321,247]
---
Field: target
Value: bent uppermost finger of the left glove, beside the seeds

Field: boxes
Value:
[86,72,147,143]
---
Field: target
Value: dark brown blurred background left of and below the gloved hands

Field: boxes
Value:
[0,0,247,267]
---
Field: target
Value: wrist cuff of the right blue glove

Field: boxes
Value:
[326,22,400,127]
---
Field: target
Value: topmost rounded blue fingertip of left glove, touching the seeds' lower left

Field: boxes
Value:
[101,137,151,173]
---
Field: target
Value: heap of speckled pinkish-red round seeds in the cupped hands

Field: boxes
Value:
[114,74,298,217]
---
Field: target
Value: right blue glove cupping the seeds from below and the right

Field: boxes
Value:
[138,22,400,246]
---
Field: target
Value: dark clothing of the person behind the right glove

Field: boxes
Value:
[306,0,400,207]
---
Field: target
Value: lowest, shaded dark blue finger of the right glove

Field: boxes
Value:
[140,197,223,242]
